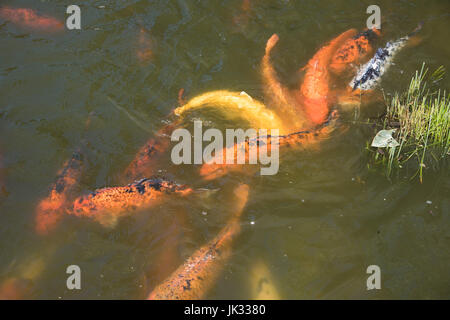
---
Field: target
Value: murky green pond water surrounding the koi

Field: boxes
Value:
[0,0,450,299]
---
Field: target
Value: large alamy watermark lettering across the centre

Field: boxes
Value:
[171,121,279,175]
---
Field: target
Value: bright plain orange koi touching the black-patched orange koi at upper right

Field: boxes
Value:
[300,29,356,125]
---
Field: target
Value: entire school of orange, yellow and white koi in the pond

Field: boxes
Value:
[0,4,422,299]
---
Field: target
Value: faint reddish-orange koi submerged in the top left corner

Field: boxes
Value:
[0,7,64,32]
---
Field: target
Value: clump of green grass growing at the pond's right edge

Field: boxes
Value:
[368,63,450,182]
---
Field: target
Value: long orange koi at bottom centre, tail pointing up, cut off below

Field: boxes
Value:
[147,185,248,300]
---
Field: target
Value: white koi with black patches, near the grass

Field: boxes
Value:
[349,23,423,91]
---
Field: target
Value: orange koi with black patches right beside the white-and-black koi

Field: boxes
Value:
[329,28,381,74]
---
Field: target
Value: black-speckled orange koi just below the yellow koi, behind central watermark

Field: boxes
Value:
[200,111,338,180]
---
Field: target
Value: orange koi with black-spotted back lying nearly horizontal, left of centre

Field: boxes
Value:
[67,179,193,227]
